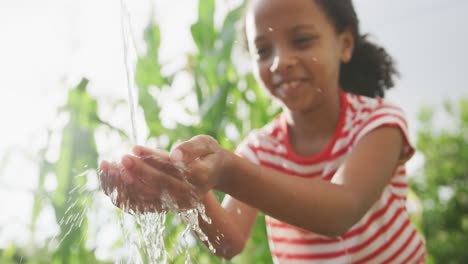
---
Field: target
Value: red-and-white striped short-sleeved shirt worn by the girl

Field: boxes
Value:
[237,92,425,264]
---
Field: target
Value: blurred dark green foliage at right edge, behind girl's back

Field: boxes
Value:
[411,98,468,264]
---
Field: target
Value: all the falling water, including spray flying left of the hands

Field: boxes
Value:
[53,0,219,264]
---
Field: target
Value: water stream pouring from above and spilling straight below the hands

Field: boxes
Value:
[120,0,215,264]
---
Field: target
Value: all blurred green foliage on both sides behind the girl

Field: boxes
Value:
[0,0,468,263]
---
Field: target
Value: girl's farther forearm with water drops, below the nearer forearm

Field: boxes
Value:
[196,192,248,259]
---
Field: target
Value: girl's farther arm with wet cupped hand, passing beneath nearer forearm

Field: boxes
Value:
[111,146,257,259]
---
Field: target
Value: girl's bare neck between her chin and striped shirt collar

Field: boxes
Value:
[284,88,341,142]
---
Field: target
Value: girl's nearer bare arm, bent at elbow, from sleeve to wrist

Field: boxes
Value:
[216,127,403,236]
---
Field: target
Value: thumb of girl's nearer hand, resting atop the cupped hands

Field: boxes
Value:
[169,135,218,164]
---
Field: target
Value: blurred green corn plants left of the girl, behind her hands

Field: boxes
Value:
[0,0,278,263]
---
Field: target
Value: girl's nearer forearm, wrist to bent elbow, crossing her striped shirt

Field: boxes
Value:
[218,154,362,236]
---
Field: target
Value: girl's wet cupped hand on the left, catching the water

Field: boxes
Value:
[100,146,201,213]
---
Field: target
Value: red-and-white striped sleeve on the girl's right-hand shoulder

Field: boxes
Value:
[353,104,415,162]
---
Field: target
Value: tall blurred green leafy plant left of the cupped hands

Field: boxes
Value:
[51,79,98,263]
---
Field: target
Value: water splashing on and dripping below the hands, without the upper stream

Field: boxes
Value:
[103,155,216,264]
